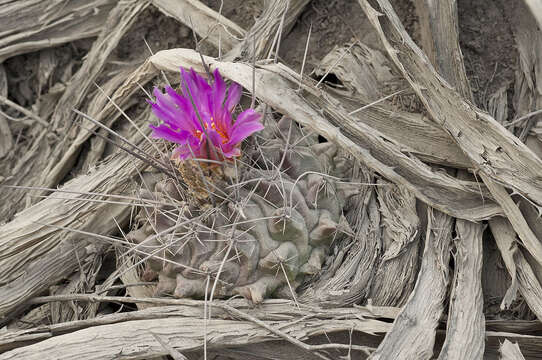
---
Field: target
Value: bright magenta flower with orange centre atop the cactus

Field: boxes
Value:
[149,68,263,160]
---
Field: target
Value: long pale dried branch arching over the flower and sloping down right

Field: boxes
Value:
[147,49,500,221]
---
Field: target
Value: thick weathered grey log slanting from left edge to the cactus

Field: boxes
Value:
[0,112,153,323]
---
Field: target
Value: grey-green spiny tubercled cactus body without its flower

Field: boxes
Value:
[127,118,355,303]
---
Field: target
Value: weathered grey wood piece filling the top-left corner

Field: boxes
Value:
[0,0,116,63]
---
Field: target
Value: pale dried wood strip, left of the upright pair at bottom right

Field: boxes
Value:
[370,208,453,359]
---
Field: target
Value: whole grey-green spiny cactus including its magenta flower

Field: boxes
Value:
[127,67,353,303]
